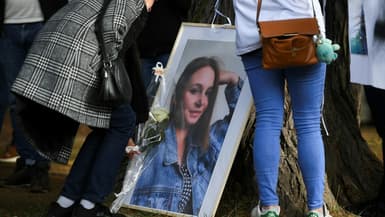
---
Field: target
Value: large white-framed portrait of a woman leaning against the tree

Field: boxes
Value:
[115,23,252,217]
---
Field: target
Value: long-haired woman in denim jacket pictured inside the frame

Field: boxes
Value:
[131,54,243,215]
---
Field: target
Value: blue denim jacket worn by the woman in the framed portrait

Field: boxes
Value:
[130,82,242,215]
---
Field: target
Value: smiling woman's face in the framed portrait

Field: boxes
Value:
[183,66,215,126]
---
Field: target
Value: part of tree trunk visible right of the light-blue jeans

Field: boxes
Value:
[324,0,383,206]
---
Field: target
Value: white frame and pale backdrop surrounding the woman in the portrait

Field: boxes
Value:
[114,23,252,217]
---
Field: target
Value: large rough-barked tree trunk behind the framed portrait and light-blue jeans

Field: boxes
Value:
[190,0,383,216]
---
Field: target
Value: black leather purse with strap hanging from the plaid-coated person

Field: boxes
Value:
[96,0,132,107]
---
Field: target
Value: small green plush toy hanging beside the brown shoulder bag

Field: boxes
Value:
[316,37,340,64]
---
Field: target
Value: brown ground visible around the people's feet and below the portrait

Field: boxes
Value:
[0,110,382,217]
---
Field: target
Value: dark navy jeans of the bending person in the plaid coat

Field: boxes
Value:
[61,105,136,203]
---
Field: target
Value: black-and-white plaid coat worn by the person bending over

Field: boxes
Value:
[12,0,147,162]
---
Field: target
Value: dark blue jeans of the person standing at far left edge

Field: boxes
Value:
[0,22,46,161]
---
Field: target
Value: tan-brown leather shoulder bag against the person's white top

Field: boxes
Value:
[257,0,320,69]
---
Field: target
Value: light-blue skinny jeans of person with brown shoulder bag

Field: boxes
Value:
[242,50,326,209]
